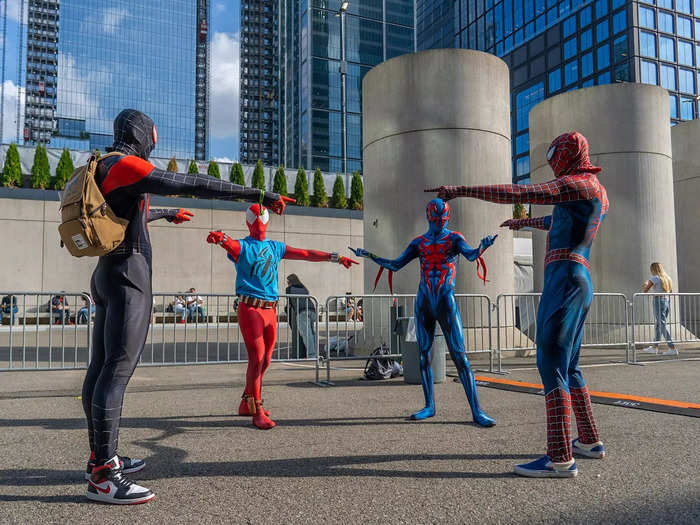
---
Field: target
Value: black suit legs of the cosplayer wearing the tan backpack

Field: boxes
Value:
[83,253,153,464]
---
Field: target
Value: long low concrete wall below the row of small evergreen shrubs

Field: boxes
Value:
[0,189,363,300]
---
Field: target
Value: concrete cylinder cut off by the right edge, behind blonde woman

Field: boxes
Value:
[671,120,700,292]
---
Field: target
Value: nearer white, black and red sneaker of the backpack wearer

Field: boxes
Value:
[86,456,156,505]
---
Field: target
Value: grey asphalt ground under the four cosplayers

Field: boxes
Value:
[0,361,700,524]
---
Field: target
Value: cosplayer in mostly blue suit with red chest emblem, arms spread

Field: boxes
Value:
[350,199,496,427]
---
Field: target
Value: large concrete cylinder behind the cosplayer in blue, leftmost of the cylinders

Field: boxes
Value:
[362,49,513,297]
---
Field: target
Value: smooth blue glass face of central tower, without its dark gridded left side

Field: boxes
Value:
[270,0,415,172]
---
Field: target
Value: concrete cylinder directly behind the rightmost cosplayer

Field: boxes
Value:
[530,83,678,295]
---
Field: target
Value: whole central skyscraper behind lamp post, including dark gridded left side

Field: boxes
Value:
[240,0,415,172]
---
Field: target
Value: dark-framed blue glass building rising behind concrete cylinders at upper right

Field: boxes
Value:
[417,0,700,182]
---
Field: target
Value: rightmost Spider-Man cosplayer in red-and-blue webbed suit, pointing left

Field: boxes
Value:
[427,132,608,477]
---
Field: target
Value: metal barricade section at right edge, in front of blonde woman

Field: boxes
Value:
[630,293,700,364]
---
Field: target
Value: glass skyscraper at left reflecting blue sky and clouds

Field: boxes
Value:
[24,0,210,159]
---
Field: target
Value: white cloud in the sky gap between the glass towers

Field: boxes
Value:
[210,32,240,138]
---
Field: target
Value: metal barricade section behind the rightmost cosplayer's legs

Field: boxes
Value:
[496,293,630,372]
